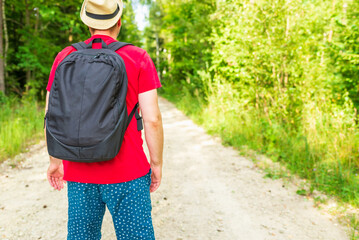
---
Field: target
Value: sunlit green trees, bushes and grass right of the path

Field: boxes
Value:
[148,0,359,205]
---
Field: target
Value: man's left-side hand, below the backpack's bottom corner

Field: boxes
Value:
[47,156,64,191]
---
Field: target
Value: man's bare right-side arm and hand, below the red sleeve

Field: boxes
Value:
[138,89,163,192]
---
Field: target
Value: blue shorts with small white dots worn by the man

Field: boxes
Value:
[67,170,155,240]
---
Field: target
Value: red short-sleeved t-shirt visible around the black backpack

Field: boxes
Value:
[46,35,161,184]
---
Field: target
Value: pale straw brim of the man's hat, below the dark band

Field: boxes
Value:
[80,0,123,30]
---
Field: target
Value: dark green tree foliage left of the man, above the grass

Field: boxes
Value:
[5,0,86,99]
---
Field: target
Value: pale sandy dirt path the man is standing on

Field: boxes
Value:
[0,99,349,240]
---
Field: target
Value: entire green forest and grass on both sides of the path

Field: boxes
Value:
[0,0,359,206]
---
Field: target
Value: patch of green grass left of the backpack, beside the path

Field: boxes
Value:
[0,96,44,163]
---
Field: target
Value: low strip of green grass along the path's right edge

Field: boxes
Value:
[161,89,359,207]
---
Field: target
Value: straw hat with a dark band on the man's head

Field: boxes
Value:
[80,0,123,30]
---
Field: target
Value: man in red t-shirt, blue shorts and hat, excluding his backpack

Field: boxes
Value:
[45,0,163,240]
